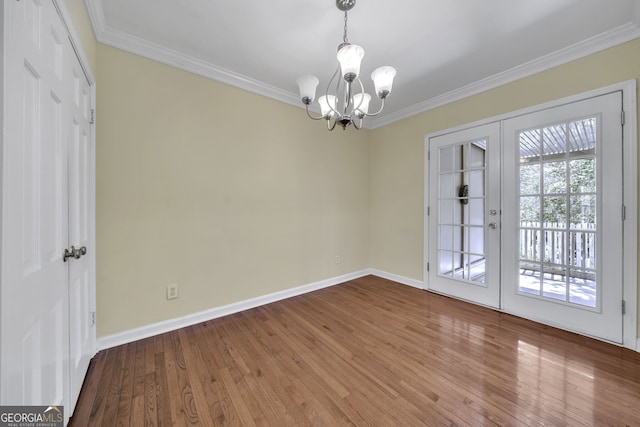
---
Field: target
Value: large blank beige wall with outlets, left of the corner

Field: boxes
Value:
[96,45,370,336]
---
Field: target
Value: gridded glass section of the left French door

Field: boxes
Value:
[438,140,487,285]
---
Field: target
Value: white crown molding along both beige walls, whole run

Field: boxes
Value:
[85,0,640,129]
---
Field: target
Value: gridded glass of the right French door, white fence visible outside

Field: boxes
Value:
[518,118,598,307]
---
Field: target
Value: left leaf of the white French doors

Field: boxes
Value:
[428,123,500,308]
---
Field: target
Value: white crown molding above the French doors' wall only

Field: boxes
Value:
[371,20,640,129]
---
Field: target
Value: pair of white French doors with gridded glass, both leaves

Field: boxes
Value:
[426,92,623,343]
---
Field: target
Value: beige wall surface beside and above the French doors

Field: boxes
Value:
[370,40,640,332]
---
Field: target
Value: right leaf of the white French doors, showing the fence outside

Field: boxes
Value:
[502,92,623,343]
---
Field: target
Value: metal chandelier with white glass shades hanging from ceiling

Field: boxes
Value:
[296,0,396,131]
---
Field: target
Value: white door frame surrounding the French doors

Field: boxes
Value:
[423,80,640,351]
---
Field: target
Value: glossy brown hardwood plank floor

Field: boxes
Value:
[70,276,640,427]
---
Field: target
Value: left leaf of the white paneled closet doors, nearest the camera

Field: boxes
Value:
[1,0,73,417]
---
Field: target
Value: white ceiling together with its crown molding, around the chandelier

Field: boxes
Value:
[86,0,640,127]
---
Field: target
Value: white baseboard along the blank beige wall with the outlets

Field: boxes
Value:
[97,269,372,351]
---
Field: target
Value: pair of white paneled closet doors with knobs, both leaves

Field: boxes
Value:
[0,0,95,422]
